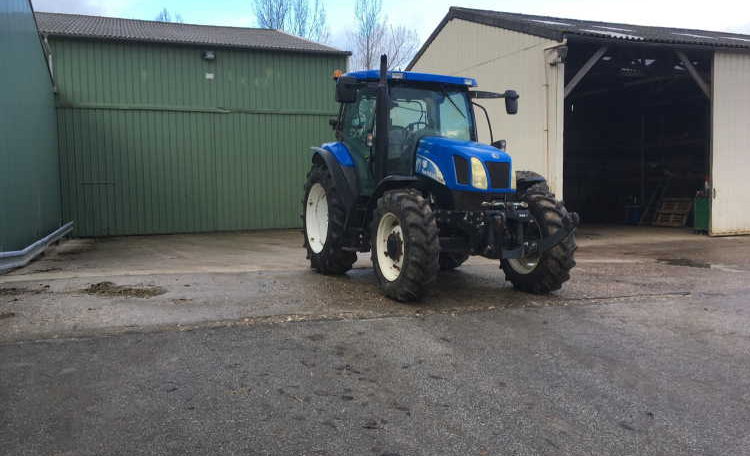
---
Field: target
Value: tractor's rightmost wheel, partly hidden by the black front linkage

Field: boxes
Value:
[501,183,576,294]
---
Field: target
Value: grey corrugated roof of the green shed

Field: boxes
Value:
[35,12,350,55]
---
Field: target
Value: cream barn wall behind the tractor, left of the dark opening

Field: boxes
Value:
[413,19,565,197]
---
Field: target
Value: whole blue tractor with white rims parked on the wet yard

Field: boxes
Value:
[302,56,578,301]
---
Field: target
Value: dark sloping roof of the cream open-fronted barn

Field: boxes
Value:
[407,6,750,68]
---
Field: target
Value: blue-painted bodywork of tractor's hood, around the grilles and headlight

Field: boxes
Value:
[417,136,515,193]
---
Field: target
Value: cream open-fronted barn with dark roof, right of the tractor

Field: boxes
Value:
[408,7,750,235]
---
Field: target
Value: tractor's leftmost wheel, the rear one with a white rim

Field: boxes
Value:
[302,163,357,274]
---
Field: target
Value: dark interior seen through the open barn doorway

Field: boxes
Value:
[563,42,711,225]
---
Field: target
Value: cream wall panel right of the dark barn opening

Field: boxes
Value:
[710,52,750,236]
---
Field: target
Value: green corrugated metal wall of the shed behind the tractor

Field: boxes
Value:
[50,38,346,236]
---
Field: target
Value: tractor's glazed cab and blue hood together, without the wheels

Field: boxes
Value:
[332,70,518,195]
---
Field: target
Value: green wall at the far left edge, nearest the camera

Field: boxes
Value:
[0,0,60,252]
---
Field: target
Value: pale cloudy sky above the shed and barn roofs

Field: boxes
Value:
[32,0,750,48]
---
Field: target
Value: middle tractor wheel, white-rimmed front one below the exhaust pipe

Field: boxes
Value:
[371,190,440,301]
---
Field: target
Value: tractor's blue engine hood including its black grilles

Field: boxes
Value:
[416,136,513,193]
